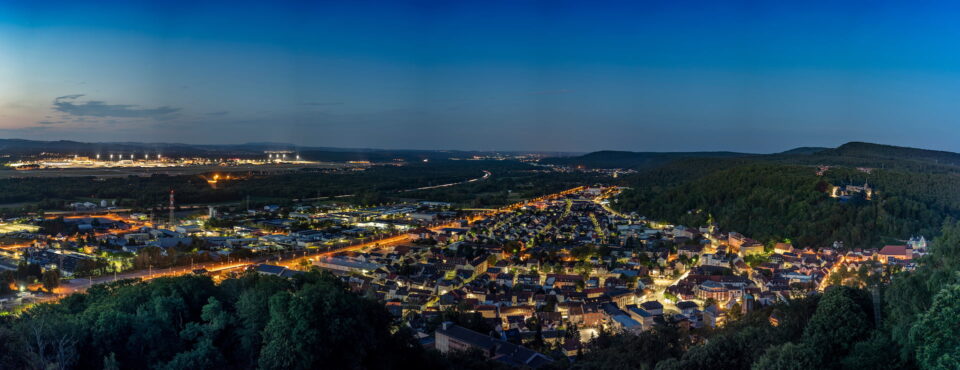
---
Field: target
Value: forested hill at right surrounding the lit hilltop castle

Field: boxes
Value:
[616,143,960,247]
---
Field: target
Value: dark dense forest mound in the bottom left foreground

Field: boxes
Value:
[0,272,510,370]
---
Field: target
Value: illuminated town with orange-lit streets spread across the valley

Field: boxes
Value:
[0,186,926,367]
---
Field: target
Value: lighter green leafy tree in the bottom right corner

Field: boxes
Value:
[910,284,960,369]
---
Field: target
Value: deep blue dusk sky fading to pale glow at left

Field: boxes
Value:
[0,0,960,152]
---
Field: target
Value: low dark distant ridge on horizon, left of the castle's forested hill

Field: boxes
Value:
[543,150,755,169]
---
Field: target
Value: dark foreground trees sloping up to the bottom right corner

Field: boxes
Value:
[552,220,960,370]
